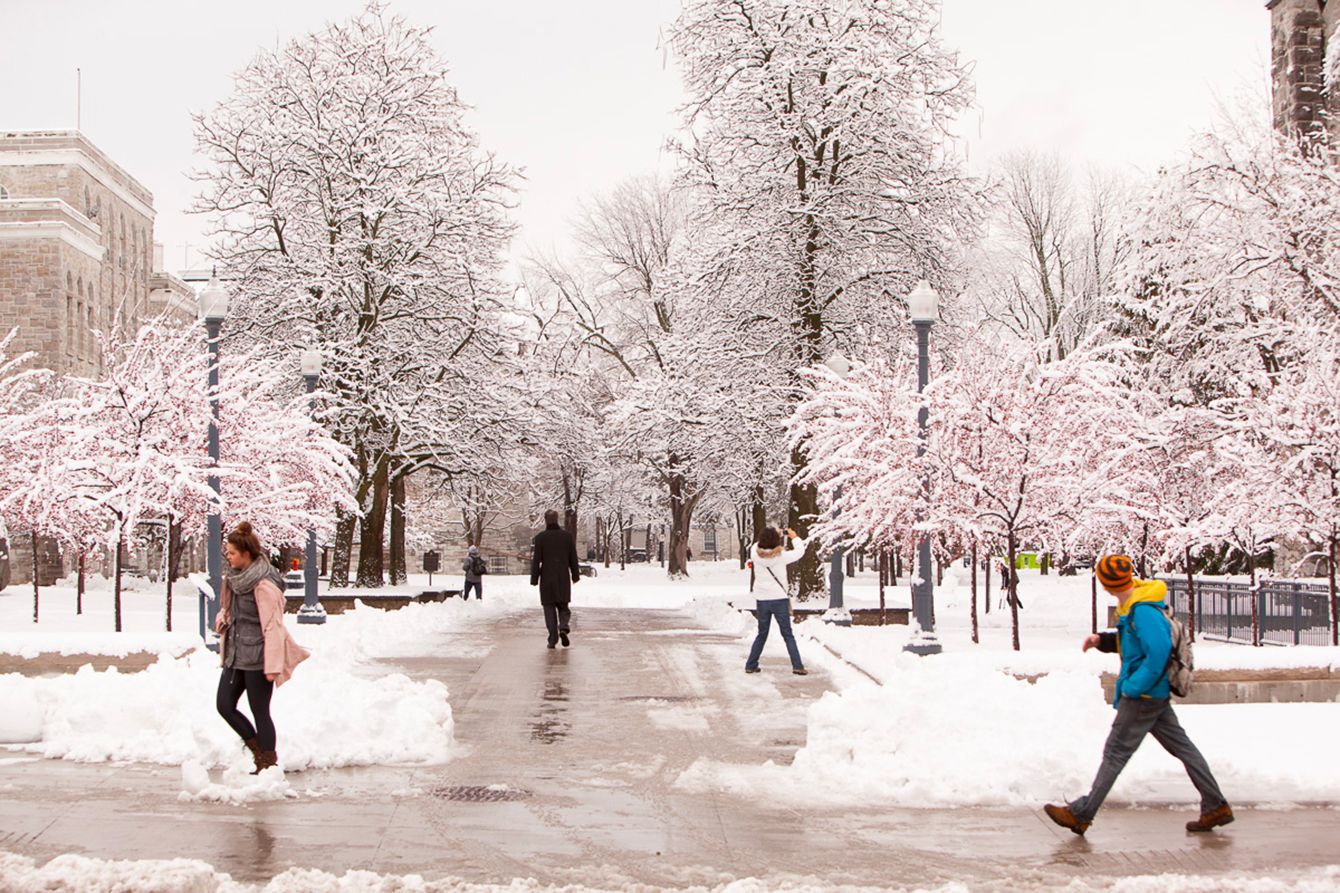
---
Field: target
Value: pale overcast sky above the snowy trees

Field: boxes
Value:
[0,0,1270,270]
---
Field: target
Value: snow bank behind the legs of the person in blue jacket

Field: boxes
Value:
[677,654,1340,807]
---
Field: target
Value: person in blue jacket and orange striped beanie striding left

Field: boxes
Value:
[1044,555,1233,834]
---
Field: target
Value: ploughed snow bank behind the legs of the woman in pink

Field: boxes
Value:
[0,650,454,770]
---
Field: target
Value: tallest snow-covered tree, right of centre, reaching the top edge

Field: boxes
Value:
[671,0,978,595]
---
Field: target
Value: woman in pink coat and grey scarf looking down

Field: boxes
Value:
[214,522,308,775]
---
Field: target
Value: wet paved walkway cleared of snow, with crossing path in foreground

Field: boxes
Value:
[0,600,1340,890]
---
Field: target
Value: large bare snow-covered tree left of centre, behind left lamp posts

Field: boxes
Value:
[194,0,515,586]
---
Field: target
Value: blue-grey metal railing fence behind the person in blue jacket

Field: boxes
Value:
[1160,577,1332,645]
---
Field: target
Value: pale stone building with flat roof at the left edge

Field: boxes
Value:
[0,130,196,583]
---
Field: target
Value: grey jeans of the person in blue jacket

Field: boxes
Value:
[1069,697,1227,822]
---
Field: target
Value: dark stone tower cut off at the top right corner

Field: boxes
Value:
[1266,0,1340,145]
